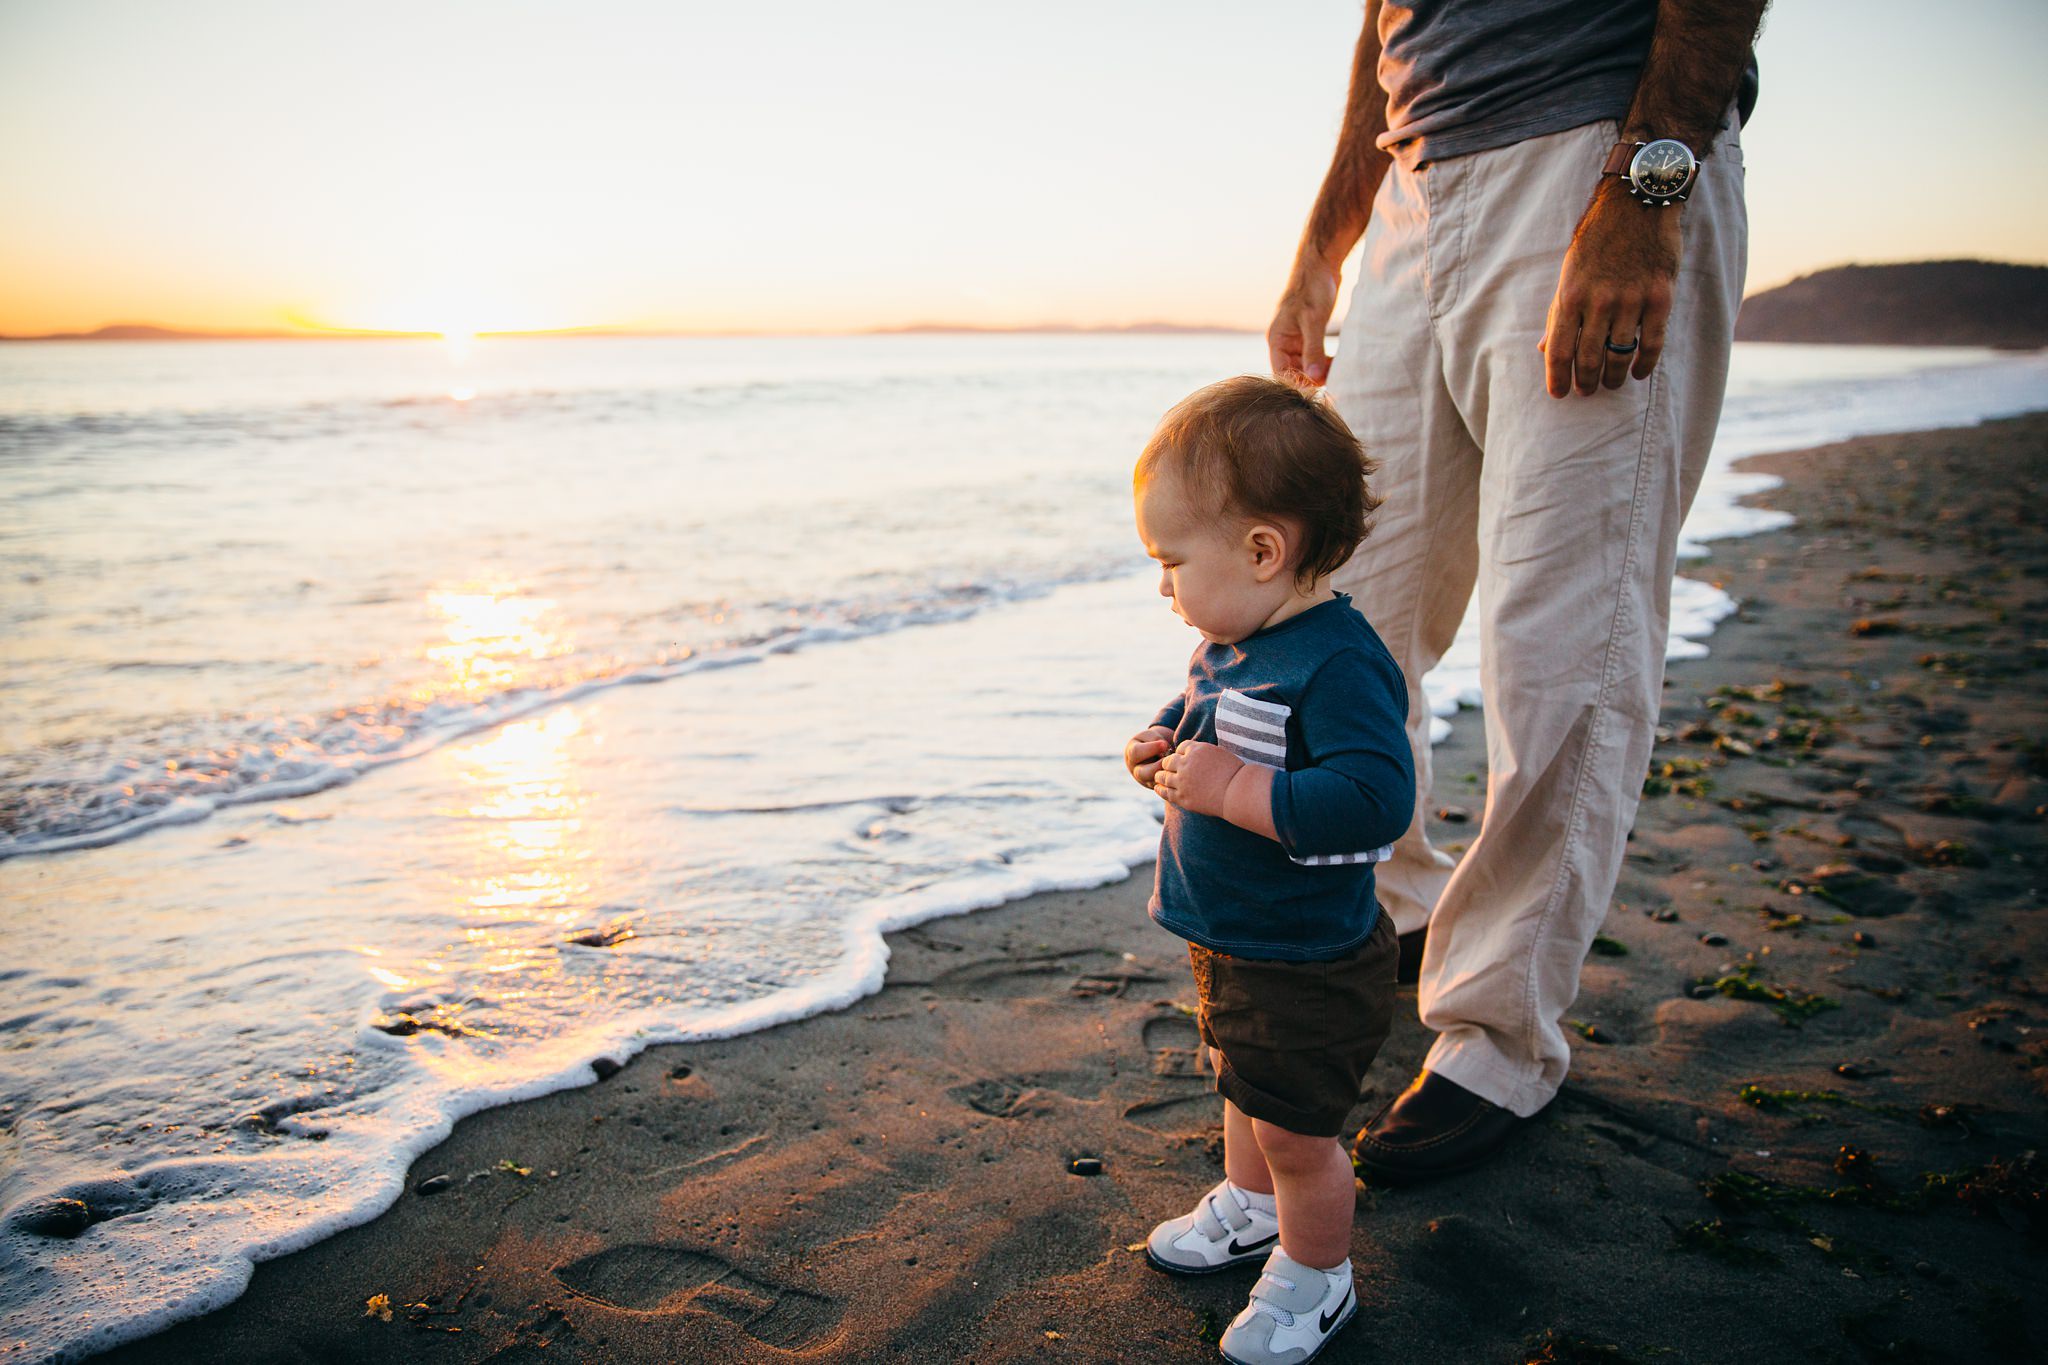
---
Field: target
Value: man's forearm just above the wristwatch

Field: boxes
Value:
[1622,0,1769,153]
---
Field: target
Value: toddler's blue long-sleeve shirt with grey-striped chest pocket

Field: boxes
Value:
[1149,593,1415,962]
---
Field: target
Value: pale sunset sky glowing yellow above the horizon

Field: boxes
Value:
[0,0,2048,336]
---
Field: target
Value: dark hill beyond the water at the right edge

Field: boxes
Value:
[1735,260,2048,350]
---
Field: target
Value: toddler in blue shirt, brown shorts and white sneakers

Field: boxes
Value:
[1124,377,1415,1365]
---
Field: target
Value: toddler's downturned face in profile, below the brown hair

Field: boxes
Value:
[1137,471,1286,645]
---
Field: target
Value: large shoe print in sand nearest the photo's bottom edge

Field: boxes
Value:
[555,1242,842,1351]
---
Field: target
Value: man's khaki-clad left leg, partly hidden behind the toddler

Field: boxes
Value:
[1329,154,1479,933]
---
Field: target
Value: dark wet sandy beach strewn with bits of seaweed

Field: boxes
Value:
[104,415,2048,1365]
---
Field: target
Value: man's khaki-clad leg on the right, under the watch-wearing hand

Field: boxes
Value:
[1419,123,1747,1115]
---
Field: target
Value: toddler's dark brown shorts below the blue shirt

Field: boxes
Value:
[1188,911,1401,1138]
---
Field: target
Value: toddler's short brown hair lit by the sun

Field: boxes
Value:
[1133,375,1380,587]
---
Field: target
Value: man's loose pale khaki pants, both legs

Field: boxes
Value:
[1329,123,1747,1115]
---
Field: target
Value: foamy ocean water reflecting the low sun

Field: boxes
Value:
[0,336,2048,1359]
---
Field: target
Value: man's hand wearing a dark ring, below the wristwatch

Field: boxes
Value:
[1538,176,1683,399]
